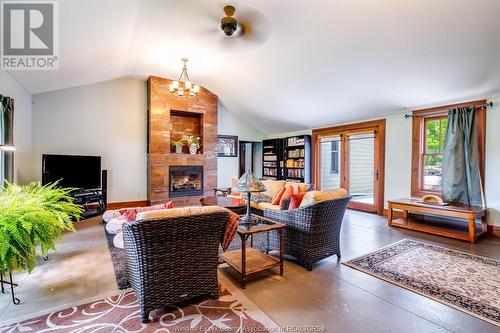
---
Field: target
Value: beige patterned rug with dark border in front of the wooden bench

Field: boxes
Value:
[343,239,500,326]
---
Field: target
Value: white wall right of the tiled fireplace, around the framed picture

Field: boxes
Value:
[217,103,266,187]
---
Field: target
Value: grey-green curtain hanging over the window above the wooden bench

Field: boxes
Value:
[442,107,483,206]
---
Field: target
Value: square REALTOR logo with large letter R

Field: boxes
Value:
[0,1,59,70]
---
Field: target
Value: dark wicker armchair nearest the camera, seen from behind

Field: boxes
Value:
[123,212,229,323]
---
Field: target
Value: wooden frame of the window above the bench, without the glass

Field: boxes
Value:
[411,100,487,197]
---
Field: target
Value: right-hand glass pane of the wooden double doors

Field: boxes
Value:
[348,132,375,204]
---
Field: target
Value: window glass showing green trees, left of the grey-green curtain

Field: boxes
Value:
[421,116,448,191]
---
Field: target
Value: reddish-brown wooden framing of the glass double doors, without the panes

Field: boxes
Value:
[312,119,385,215]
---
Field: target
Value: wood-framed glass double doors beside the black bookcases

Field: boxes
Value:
[313,122,385,214]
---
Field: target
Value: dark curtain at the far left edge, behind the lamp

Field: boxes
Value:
[0,95,14,185]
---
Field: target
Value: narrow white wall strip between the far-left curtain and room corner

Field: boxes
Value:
[0,71,33,184]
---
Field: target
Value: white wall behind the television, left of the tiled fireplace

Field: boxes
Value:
[33,79,147,202]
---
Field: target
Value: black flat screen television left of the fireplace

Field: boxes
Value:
[42,154,101,190]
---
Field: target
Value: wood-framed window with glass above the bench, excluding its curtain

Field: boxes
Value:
[411,100,487,197]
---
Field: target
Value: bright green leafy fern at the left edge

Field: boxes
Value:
[0,182,82,273]
